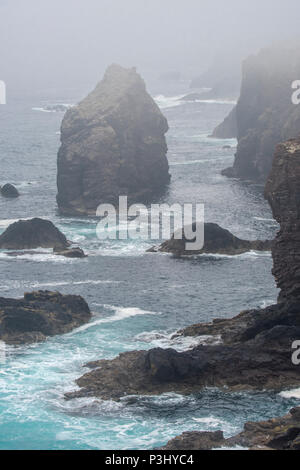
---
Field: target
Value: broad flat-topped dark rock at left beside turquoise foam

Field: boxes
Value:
[0,291,91,345]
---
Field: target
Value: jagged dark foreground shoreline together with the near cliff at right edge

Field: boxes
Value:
[66,135,300,412]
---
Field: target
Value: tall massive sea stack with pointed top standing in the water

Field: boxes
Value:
[57,65,170,215]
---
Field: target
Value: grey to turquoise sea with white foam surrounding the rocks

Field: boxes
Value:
[0,86,299,449]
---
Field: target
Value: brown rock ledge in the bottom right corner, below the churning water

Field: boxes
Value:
[162,408,300,450]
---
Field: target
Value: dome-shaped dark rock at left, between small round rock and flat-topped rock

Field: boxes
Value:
[0,218,69,250]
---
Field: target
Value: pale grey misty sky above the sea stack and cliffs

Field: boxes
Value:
[0,0,300,95]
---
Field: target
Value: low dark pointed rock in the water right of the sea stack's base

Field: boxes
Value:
[149,223,272,256]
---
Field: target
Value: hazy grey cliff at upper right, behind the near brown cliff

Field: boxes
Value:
[218,46,300,182]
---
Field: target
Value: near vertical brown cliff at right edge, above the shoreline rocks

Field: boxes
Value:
[265,139,300,300]
